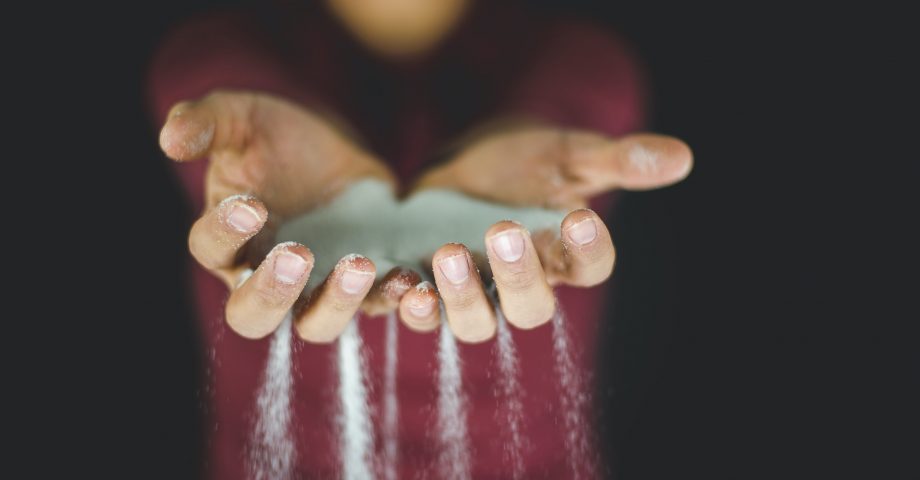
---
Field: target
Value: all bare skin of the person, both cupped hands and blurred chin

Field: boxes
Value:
[160,4,692,343]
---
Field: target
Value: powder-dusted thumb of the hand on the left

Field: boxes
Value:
[160,91,256,161]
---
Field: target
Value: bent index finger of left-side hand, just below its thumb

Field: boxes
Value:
[188,195,268,283]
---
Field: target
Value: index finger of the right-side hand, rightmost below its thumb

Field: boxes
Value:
[534,208,616,287]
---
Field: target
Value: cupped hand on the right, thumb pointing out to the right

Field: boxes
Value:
[400,127,693,342]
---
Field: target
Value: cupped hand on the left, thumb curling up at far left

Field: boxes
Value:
[160,91,419,342]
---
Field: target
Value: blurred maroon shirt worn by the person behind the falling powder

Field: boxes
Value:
[148,2,643,479]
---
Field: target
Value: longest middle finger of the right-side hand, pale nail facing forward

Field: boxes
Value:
[486,221,556,328]
